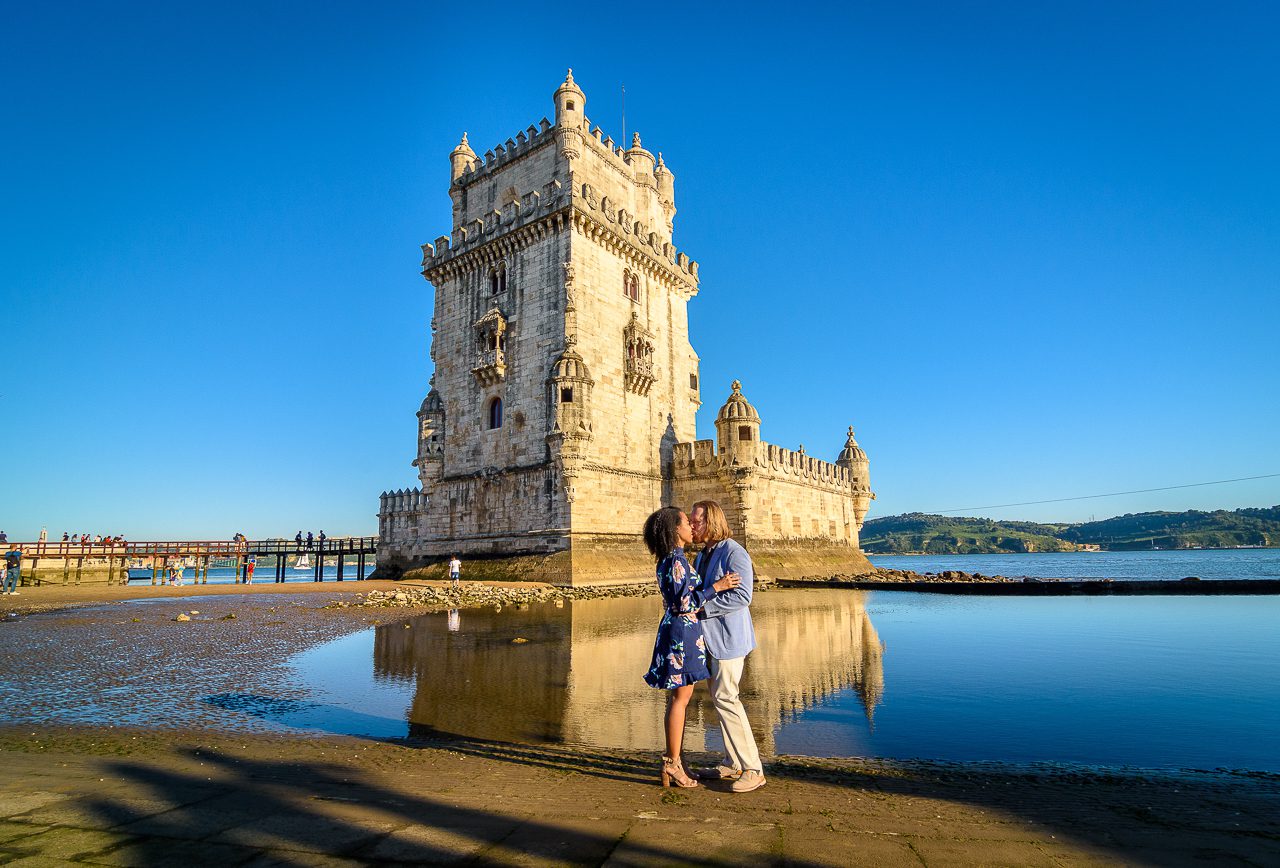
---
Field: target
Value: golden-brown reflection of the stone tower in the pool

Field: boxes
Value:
[374,590,884,753]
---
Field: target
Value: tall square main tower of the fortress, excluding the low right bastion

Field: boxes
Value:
[381,72,700,583]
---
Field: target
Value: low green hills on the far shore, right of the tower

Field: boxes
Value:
[861,506,1280,554]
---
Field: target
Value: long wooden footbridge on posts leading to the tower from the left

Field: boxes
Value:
[0,536,378,585]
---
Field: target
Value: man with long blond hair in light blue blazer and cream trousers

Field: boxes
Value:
[689,501,764,792]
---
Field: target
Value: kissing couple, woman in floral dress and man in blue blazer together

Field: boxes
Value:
[644,501,764,792]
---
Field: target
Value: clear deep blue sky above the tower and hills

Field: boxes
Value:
[0,1,1280,539]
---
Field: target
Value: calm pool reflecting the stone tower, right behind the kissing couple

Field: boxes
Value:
[275,590,1280,771]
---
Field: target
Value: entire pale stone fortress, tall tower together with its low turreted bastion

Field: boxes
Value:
[379,72,873,584]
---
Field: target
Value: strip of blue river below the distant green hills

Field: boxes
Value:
[870,548,1280,580]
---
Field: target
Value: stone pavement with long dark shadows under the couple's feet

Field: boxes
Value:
[0,727,1280,865]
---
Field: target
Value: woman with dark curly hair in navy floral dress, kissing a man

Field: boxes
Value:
[644,507,739,786]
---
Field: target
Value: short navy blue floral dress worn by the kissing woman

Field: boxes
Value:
[644,548,716,690]
